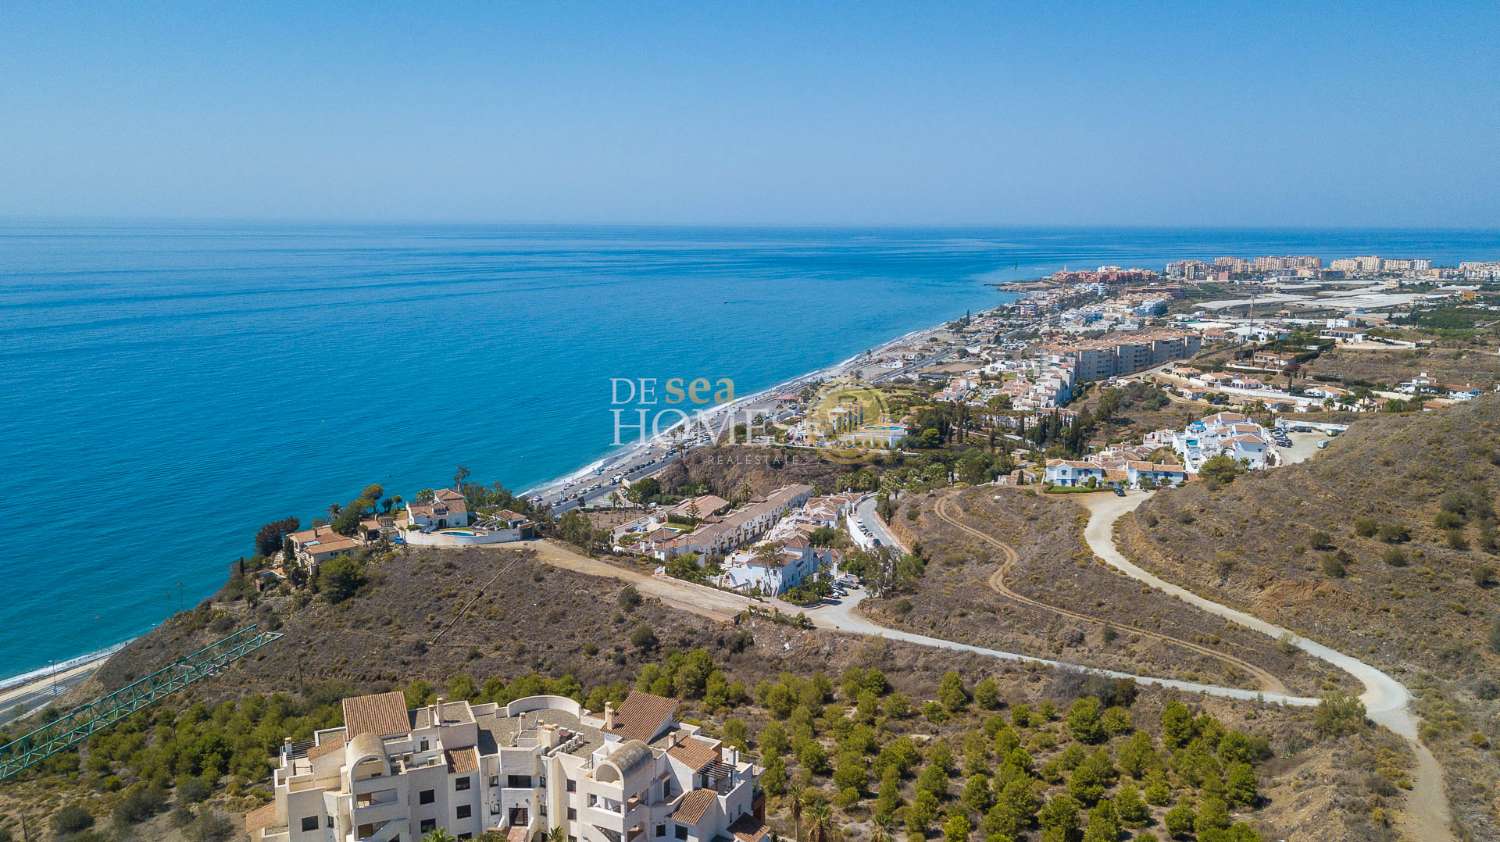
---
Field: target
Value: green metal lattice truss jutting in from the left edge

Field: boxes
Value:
[0,626,282,780]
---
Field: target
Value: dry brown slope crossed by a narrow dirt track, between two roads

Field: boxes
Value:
[863,486,1349,696]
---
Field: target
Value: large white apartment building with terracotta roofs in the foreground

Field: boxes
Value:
[246,692,770,842]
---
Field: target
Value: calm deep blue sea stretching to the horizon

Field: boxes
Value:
[0,222,1500,675]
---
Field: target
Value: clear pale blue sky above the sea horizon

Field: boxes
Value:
[0,0,1500,228]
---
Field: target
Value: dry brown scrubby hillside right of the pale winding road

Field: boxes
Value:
[1118,395,1500,839]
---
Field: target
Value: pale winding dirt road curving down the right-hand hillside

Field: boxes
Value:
[1082,492,1454,842]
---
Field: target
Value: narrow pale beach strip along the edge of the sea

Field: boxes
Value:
[0,302,984,690]
